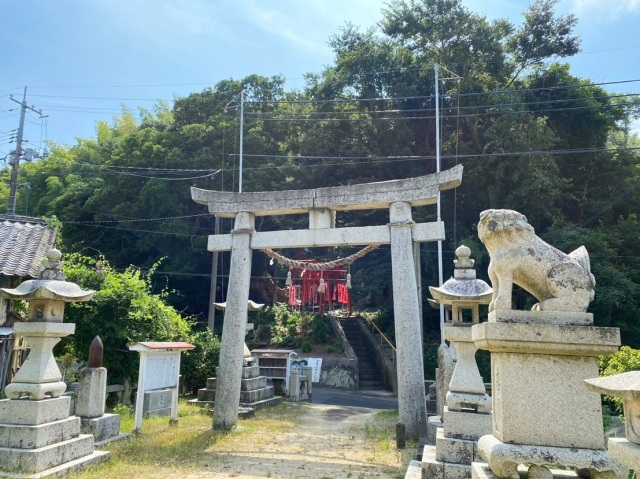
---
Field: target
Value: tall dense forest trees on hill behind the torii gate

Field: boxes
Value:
[0,0,640,364]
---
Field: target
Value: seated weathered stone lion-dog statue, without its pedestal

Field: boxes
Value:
[478,210,596,312]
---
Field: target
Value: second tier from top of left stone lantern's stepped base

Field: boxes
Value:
[0,417,80,449]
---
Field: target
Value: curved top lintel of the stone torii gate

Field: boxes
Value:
[191,165,462,218]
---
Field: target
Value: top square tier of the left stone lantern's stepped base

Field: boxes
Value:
[0,396,71,426]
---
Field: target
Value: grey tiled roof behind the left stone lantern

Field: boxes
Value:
[0,215,56,278]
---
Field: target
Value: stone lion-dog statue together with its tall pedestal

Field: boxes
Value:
[472,210,626,479]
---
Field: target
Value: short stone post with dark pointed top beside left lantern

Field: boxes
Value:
[76,336,128,446]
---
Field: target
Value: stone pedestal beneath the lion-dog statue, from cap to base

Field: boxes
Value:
[472,310,627,479]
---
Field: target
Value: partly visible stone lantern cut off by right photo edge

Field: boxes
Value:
[585,371,640,472]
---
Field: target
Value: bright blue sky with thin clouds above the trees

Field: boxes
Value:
[0,0,640,159]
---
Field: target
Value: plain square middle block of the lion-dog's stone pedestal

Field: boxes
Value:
[490,352,605,450]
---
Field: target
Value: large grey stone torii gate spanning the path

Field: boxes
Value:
[191,166,462,438]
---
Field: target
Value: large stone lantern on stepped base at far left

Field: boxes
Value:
[0,249,109,477]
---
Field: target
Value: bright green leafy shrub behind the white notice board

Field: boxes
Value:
[58,254,220,389]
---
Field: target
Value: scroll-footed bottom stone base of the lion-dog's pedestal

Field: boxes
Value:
[478,435,629,479]
